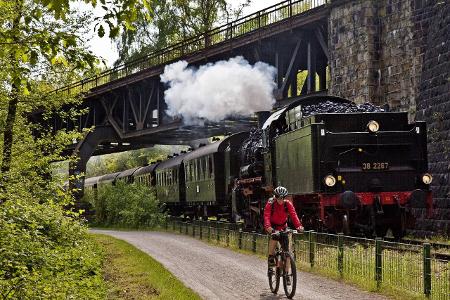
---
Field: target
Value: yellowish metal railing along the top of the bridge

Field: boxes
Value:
[54,0,330,96]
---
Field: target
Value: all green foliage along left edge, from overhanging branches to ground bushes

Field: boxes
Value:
[0,0,154,299]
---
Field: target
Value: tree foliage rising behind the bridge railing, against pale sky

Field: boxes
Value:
[115,0,251,65]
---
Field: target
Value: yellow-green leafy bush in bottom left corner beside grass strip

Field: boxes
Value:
[0,199,106,299]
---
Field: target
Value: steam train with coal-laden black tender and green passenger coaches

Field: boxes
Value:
[85,96,432,238]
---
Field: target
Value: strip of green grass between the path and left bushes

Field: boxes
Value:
[92,234,201,300]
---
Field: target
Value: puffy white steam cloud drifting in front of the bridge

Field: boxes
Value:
[161,56,276,124]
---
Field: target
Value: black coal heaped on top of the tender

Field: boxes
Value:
[302,101,385,117]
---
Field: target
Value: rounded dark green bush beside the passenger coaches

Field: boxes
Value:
[85,181,166,228]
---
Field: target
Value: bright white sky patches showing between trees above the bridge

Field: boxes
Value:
[88,0,283,67]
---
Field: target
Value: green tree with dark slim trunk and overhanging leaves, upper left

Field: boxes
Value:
[0,0,150,191]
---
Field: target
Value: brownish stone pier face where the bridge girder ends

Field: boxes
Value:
[328,0,379,103]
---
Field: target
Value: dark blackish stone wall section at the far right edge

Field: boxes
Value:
[416,1,450,236]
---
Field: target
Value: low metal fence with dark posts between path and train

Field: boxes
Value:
[166,219,450,300]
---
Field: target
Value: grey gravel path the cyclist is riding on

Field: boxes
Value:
[92,230,386,300]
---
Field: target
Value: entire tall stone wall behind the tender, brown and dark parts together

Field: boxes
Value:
[328,0,450,235]
